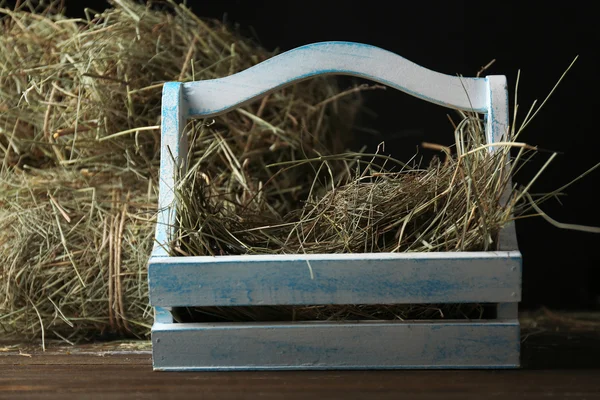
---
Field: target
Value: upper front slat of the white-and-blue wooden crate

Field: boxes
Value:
[148,252,521,307]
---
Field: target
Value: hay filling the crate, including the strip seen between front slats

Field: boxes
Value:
[171,113,511,322]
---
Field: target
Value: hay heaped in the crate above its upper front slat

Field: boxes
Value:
[171,110,520,255]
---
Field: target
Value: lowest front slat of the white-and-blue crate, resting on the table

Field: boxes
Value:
[152,321,519,370]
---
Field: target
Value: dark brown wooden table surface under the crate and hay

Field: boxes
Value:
[0,314,600,400]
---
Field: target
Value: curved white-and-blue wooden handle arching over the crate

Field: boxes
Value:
[183,42,488,117]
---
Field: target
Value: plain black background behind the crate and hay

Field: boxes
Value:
[10,0,600,309]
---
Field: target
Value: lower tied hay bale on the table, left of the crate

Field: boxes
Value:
[0,168,156,341]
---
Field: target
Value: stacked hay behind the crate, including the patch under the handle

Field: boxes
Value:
[0,0,361,341]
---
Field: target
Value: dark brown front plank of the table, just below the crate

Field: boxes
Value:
[0,364,600,400]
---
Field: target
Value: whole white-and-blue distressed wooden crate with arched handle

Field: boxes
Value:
[148,42,521,370]
